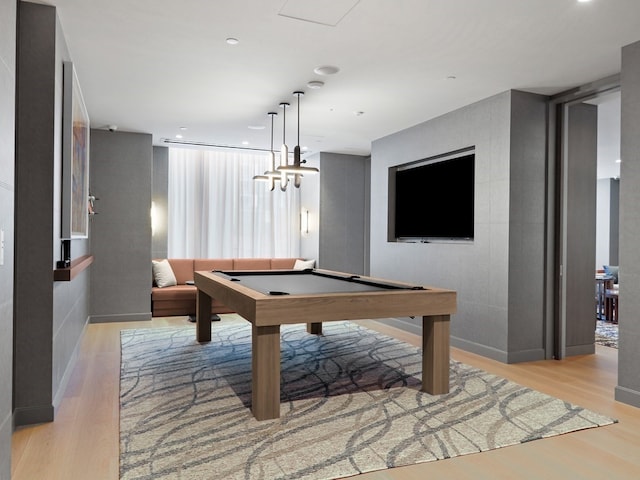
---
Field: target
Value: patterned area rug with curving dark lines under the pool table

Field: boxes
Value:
[120,319,614,480]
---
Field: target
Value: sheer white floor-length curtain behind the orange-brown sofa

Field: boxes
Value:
[167,148,300,258]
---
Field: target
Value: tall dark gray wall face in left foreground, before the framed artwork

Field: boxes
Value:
[14,3,56,425]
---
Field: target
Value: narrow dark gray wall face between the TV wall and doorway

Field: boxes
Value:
[504,90,547,363]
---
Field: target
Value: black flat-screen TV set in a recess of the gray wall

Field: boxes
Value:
[389,148,475,242]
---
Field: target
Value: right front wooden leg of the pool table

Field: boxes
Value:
[422,315,449,395]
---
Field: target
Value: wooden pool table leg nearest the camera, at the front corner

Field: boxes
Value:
[251,325,280,420]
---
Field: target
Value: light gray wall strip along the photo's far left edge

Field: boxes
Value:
[0,0,17,474]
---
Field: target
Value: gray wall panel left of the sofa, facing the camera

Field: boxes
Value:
[90,129,153,323]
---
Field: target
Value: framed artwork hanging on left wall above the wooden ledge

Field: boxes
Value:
[61,62,89,239]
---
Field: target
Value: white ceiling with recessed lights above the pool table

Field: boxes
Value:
[51,0,640,162]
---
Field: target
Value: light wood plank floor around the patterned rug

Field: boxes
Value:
[12,317,640,480]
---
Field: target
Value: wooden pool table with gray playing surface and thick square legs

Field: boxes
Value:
[194,270,456,420]
